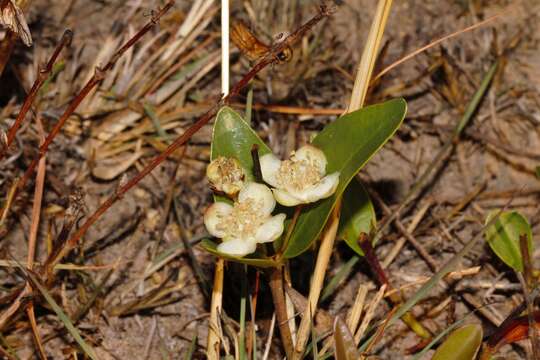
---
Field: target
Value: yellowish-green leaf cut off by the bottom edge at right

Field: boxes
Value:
[431,324,482,360]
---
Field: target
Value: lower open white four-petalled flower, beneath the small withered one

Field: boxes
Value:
[204,182,285,256]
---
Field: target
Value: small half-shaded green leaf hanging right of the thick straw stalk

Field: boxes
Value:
[338,180,376,256]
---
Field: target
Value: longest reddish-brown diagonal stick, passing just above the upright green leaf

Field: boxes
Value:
[43,1,334,272]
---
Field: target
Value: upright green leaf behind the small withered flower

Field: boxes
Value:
[211,106,271,172]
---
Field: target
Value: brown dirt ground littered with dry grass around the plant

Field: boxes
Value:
[0,0,540,359]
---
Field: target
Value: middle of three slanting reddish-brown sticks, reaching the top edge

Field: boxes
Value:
[2,1,174,219]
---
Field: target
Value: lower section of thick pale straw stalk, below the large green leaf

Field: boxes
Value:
[292,201,341,360]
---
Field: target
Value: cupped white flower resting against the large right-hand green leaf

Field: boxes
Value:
[260,145,339,206]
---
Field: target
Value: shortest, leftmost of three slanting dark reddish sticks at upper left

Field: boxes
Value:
[0,29,73,160]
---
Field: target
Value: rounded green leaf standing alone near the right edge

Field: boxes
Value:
[486,211,533,271]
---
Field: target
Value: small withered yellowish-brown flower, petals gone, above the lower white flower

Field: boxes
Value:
[206,156,245,196]
